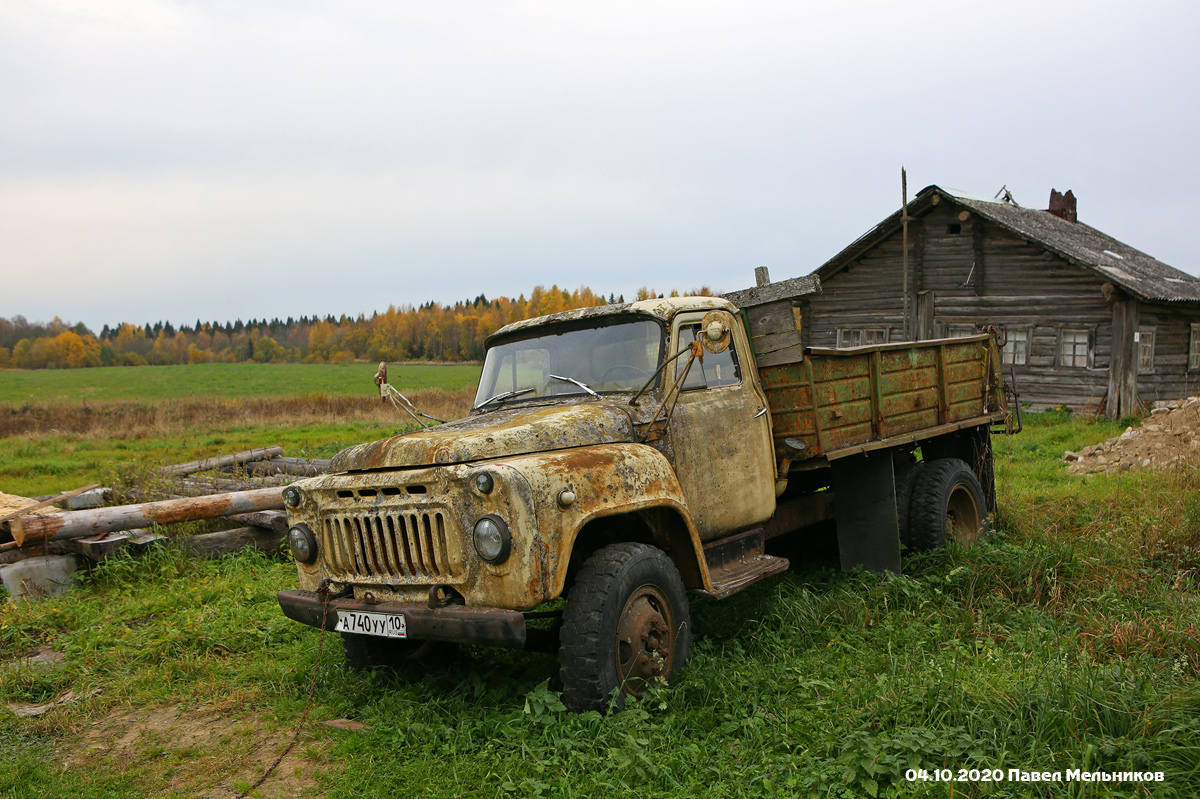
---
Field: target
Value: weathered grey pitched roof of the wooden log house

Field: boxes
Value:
[814,186,1200,302]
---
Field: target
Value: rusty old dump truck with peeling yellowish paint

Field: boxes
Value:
[278,278,1009,711]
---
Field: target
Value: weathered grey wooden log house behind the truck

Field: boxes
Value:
[802,186,1200,417]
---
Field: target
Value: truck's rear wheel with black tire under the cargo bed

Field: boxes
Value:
[908,458,988,552]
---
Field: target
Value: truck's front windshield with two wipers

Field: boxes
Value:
[475,318,664,408]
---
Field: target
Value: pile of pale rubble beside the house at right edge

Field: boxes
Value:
[1062,397,1200,474]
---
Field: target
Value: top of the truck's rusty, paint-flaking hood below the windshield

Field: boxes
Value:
[330,402,634,471]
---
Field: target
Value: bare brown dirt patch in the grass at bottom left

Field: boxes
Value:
[62,705,324,799]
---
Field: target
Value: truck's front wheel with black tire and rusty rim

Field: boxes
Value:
[558,543,691,713]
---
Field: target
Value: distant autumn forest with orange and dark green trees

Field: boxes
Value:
[0,286,712,370]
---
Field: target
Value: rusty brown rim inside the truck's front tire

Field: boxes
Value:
[616,585,676,696]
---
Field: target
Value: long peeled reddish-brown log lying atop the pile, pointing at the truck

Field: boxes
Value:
[11,488,283,546]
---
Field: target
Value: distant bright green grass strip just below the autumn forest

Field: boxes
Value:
[0,364,480,404]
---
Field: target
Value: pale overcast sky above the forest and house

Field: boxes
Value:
[0,0,1200,330]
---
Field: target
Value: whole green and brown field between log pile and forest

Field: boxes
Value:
[0,364,479,497]
